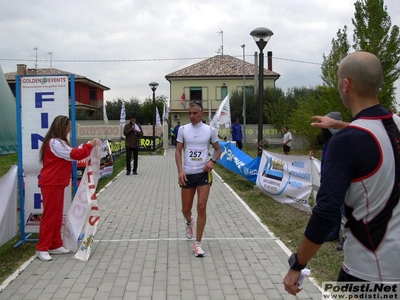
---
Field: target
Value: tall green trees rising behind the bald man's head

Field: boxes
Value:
[321,0,400,109]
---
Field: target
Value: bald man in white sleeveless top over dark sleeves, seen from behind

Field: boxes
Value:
[284,51,400,295]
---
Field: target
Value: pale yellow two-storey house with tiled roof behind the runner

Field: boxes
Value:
[165,51,280,124]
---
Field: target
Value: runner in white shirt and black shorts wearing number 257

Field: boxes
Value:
[175,101,221,257]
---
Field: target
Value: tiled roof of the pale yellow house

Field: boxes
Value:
[165,55,280,79]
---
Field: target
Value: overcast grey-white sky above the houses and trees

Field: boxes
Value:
[0,0,400,102]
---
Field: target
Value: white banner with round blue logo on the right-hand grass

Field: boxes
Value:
[256,151,312,213]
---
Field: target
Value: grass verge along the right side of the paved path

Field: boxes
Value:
[215,148,343,283]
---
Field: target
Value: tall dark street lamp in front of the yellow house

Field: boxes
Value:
[250,27,274,157]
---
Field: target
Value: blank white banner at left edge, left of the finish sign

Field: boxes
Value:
[0,166,18,246]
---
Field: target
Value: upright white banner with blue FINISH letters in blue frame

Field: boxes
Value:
[19,75,71,232]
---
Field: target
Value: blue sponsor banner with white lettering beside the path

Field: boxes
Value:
[218,141,260,183]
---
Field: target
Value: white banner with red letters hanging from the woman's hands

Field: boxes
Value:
[63,139,102,260]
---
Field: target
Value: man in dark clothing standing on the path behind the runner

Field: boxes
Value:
[124,115,143,175]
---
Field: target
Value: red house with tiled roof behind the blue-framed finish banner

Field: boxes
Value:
[4,64,110,116]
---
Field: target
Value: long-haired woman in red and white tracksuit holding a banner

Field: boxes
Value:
[36,116,96,261]
